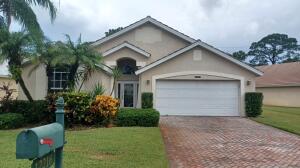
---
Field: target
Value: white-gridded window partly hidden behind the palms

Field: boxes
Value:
[48,68,70,90]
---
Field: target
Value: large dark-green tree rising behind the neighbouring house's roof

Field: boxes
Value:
[248,33,299,65]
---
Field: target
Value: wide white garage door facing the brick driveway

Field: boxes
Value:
[155,80,239,116]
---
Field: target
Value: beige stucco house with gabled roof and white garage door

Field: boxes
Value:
[22,16,262,116]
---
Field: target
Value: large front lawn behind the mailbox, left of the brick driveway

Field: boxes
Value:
[0,127,168,168]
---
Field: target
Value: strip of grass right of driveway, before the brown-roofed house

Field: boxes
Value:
[252,106,300,135]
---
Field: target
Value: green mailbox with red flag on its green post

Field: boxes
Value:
[16,97,66,168]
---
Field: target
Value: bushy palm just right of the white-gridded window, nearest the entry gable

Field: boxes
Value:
[60,35,102,91]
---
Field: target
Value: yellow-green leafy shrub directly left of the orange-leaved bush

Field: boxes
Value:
[46,92,91,127]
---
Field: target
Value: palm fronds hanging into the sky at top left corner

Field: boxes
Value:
[0,0,56,37]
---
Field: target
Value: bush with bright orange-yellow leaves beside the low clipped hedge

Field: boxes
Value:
[85,95,120,124]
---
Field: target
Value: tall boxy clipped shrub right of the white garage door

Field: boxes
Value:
[245,92,263,117]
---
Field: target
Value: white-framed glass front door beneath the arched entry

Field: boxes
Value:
[117,81,138,107]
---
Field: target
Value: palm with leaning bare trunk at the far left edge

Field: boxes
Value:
[0,29,36,101]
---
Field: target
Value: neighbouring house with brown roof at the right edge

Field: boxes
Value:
[256,62,300,107]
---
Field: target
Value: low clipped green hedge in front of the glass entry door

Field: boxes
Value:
[116,108,159,127]
